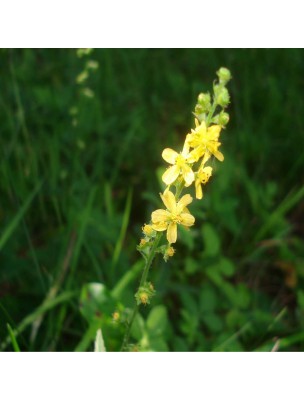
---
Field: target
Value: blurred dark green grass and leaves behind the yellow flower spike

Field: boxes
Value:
[0,49,304,351]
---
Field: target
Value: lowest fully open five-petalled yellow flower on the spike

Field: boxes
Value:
[152,190,195,243]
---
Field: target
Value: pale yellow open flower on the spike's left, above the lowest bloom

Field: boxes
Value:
[162,143,194,186]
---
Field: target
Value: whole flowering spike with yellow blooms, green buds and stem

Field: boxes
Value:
[122,68,231,350]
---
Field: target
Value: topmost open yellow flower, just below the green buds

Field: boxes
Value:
[186,119,224,161]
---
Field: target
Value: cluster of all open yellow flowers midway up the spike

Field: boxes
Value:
[151,119,224,244]
